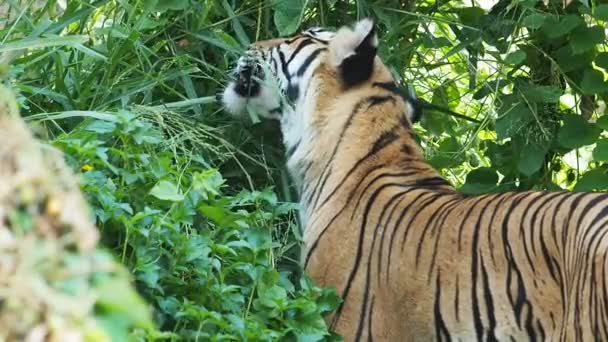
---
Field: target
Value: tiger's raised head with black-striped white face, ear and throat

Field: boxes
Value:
[222,19,415,171]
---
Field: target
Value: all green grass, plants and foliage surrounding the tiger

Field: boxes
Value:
[0,0,608,341]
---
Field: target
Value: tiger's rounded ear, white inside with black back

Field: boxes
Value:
[329,19,378,88]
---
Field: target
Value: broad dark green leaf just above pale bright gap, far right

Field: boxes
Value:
[557,114,601,149]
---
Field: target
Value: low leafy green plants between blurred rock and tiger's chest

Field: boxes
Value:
[53,111,339,341]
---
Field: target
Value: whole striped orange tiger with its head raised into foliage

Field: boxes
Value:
[221,18,608,341]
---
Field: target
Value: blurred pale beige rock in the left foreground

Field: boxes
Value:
[0,85,151,342]
